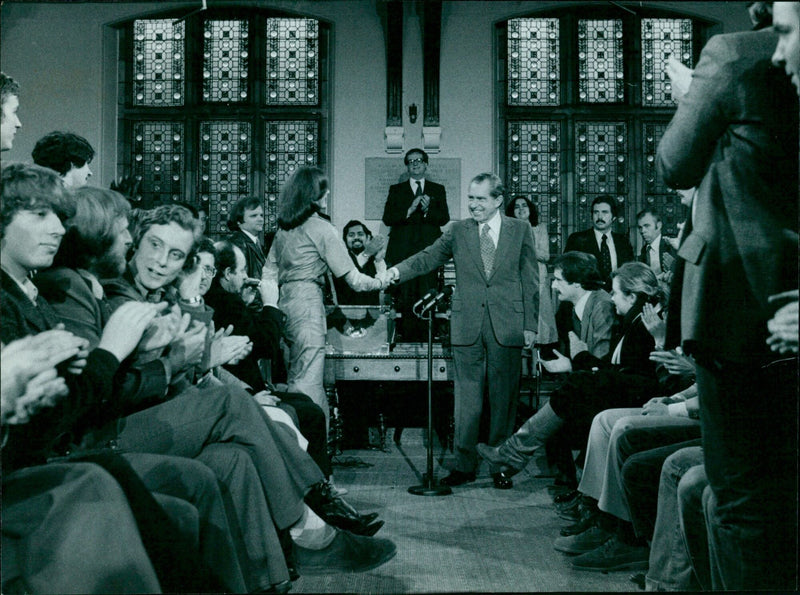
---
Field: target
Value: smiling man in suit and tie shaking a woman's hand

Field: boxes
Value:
[384,173,539,489]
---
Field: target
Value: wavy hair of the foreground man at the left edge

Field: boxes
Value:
[0,163,70,238]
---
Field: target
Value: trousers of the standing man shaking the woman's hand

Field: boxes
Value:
[453,309,522,473]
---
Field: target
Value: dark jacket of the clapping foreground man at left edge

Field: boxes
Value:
[0,271,122,472]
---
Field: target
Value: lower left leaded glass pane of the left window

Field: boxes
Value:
[132,122,185,205]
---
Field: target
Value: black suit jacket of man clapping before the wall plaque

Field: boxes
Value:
[383,179,450,266]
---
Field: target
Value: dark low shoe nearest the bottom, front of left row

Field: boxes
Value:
[295,531,397,575]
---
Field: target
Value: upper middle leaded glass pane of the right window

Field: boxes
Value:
[578,19,625,103]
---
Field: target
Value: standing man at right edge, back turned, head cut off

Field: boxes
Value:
[657,24,798,590]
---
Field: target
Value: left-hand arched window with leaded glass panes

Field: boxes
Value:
[118,9,330,235]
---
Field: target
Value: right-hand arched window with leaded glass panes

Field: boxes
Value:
[496,6,708,254]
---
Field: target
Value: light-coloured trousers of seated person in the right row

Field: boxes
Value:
[578,408,700,522]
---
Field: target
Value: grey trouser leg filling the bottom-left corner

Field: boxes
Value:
[2,463,161,593]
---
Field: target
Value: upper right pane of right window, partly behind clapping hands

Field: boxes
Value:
[642,19,692,107]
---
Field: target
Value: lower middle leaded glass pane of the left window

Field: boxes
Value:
[198,121,253,234]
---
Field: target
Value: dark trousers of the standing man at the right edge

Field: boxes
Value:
[697,356,798,590]
